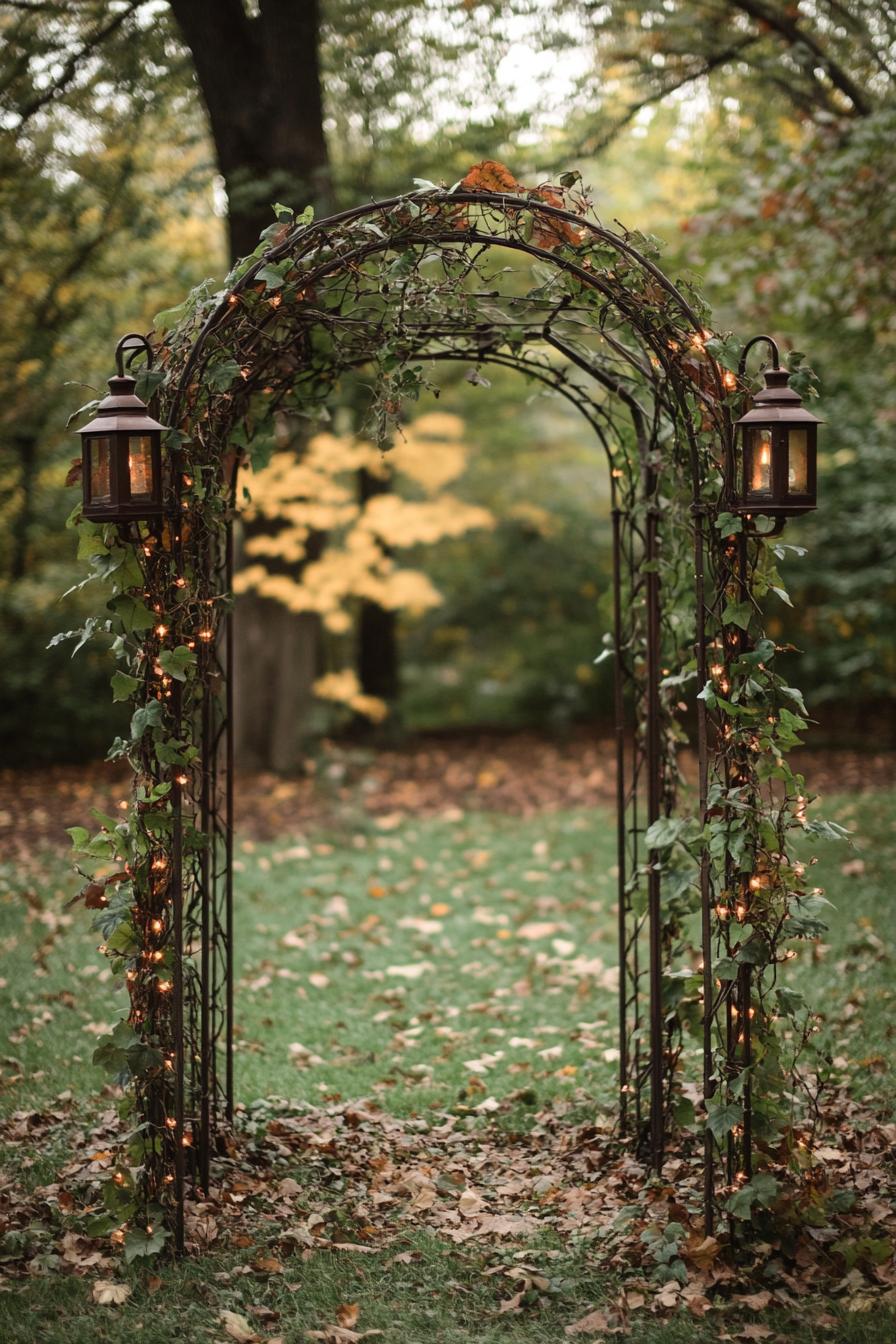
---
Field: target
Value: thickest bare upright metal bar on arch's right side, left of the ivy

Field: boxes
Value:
[646,499,665,1171]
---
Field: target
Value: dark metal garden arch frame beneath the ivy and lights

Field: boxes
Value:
[105,181,811,1246]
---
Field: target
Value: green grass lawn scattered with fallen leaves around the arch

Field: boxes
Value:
[0,794,896,1344]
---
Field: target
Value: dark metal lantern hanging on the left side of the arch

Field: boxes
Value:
[78,332,165,523]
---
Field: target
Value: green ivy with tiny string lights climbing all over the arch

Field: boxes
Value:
[61,164,838,1258]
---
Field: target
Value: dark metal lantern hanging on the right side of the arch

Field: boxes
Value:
[733,336,822,527]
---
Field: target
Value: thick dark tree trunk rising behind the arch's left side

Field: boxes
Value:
[169,0,329,770]
